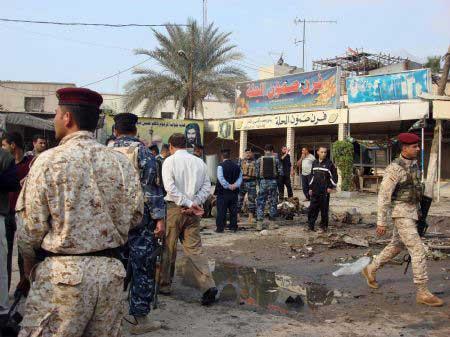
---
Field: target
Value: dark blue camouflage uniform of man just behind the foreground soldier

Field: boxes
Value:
[113,136,166,316]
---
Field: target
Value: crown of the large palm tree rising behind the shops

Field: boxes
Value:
[125,19,247,118]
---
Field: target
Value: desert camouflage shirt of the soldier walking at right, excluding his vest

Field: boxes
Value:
[377,157,419,227]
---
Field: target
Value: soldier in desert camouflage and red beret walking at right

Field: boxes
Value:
[363,133,444,306]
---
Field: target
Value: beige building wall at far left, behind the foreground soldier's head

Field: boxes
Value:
[0,82,75,114]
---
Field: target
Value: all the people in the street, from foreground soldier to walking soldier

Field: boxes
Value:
[0,88,443,337]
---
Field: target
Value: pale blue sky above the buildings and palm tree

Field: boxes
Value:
[0,0,450,93]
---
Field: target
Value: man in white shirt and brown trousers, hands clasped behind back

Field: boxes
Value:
[160,133,217,305]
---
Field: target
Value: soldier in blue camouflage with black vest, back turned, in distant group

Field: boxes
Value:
[255,144,281,230]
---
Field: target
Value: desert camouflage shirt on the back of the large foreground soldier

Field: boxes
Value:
[16,131,144,257]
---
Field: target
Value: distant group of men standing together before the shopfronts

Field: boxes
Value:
[215,144,338,233]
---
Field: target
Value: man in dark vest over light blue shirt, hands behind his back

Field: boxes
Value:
[216,149,242,233]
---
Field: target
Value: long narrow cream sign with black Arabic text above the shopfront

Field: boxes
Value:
[234,110,347,130]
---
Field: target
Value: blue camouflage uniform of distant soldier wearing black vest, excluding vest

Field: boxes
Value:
[255,154,281,221]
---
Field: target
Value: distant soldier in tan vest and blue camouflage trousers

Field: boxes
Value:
[238,148,256,224]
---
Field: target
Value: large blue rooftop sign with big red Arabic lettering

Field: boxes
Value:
[235,68,339,116]
